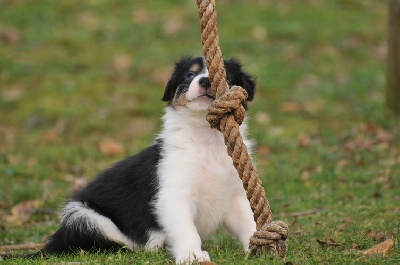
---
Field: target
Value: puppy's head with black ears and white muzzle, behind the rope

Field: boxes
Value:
[162,57,255,111]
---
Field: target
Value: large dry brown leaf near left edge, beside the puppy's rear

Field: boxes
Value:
[5,200,43,226]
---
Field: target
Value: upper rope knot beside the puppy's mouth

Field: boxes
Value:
[207,86,248,130]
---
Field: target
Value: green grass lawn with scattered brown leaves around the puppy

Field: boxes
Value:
[0,0,400,264]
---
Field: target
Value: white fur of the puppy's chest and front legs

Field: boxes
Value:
[154,106,256,263]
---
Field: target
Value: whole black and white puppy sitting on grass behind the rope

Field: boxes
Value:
[13,57,256,263]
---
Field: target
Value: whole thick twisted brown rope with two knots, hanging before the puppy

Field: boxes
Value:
[197,0,289,257]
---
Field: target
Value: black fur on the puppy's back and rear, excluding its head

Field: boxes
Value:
[42,140,162,254]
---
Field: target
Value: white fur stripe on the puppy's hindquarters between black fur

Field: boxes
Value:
[61,201,138,250]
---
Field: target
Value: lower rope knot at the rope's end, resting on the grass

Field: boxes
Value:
[250,221,289,257]
